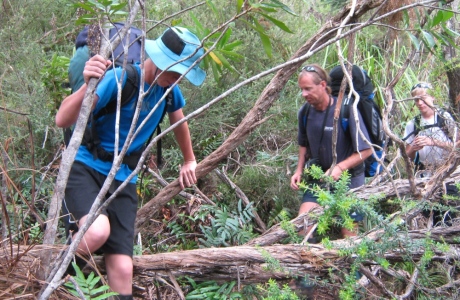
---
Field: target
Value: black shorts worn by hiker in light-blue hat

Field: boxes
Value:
[62,161,137,256]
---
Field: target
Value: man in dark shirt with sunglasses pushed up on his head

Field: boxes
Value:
[291,64,372,237]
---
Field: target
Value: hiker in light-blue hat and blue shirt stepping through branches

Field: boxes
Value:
[56,27,206,299]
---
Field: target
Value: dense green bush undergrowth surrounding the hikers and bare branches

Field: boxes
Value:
[0,0,460,300]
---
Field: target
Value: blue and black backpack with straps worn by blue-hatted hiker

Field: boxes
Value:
[64,23,173,169]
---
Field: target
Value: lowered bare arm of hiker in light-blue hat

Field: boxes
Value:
[168,109,197,188]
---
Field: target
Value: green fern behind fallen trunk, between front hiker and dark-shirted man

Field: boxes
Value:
[199,200,254,247]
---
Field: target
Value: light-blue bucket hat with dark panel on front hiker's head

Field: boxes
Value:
[145,27,206,86]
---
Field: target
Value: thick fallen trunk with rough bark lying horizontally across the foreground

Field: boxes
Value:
[81,225,460,284]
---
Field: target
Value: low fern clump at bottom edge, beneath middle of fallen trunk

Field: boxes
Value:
[185,277,242,300]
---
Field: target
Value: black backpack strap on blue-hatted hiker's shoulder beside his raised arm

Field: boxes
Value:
[94,64,139,120]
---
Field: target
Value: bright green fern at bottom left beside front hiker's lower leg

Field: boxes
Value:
[64,262,118,300]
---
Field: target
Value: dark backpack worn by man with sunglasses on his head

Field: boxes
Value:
[329,65,386,177]
